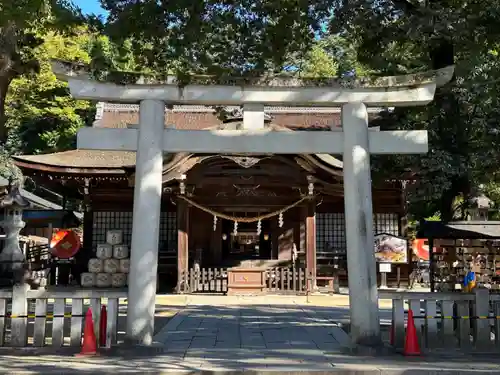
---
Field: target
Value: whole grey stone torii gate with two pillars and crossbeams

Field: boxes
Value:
[56,63,453,346]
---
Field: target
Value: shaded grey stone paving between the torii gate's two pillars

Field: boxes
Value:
[152,305,350,371]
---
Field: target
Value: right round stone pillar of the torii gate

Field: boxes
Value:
[342,103,381,346]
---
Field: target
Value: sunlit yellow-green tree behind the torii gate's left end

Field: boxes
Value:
[6,27,92,154]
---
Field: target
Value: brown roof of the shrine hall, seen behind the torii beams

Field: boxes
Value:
[14,103,374,174]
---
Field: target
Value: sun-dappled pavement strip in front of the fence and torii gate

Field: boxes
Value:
[0,347,500,375]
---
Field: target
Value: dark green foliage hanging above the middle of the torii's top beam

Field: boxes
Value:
[101,0,333,75]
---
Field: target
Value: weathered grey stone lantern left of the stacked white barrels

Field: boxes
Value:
[0,184,29,283]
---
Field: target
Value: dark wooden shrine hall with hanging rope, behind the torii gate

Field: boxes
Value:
[15,103,409,292]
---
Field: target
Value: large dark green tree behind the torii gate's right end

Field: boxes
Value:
[331,0,500,221]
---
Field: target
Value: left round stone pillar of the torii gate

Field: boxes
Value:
[127,100,165,345]
